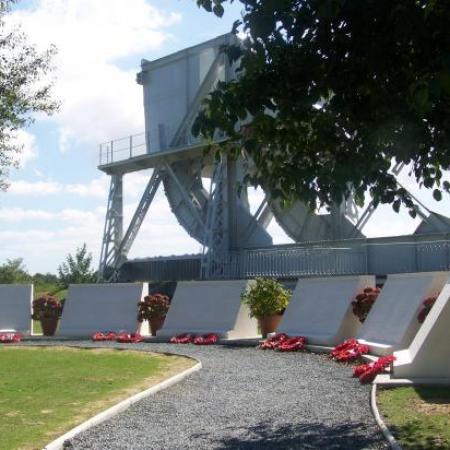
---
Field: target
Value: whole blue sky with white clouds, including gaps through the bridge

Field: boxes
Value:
[0,0,449,273]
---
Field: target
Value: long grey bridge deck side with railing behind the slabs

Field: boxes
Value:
[117,234,450,281]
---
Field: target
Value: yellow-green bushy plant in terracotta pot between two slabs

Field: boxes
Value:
[242,278,291,338]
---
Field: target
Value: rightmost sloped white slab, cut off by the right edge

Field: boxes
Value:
[392,281,450,385]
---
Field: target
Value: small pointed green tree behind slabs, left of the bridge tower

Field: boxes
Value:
[58,244,96,287]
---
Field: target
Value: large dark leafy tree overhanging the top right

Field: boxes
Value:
[193,0,450,216]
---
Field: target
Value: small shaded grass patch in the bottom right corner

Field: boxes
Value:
[378,386,450,450]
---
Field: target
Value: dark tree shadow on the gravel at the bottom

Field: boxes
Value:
[207,422,388,450]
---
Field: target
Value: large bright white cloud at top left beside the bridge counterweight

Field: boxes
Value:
[12,0,180,151]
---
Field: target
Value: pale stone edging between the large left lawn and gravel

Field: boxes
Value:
[42,358,202,450]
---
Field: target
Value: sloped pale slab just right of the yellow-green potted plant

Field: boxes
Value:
[277,275,375,347]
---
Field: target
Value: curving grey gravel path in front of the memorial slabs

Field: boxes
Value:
[24,341,388,450]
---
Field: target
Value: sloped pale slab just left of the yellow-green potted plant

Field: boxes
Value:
[156,280,258,339]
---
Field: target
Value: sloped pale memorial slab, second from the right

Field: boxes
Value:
[356,272,450,356]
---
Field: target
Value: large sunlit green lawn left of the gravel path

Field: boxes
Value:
[0,346,193,450]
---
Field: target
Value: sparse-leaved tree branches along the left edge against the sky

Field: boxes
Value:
[0,0,57,189]
